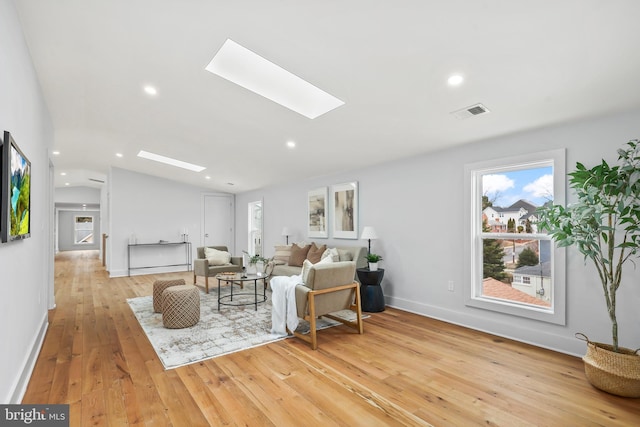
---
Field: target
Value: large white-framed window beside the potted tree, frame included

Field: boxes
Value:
[465,150,566,325]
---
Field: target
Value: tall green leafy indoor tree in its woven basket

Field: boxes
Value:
[538,140,640,397]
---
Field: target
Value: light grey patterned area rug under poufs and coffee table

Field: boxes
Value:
[127,284,364,369]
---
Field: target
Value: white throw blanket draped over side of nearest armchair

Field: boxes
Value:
[269,275,302,336]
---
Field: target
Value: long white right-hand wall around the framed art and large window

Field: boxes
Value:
[236,111,640,355]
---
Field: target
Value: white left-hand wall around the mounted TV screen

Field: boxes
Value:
[0,0,53,403]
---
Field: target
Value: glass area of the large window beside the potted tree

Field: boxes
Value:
[481,166,553,307]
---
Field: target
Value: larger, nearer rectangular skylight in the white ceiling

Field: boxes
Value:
[205,39,344,119]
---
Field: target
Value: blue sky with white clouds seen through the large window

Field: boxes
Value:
[482,166,553,207]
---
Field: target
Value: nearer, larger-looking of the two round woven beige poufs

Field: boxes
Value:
[162,285,200,329]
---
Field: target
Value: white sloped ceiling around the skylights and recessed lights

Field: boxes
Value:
[15,0,640,192]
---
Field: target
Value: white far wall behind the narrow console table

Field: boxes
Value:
[107,168,212,277]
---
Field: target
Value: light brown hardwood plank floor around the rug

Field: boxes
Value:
[23,251,640,427]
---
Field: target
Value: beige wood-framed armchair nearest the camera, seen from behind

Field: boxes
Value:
[294,261,364,350]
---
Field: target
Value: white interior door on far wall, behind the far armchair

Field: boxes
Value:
[202,195,235,254]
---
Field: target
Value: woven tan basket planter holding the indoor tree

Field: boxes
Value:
[582,337,640,397]
